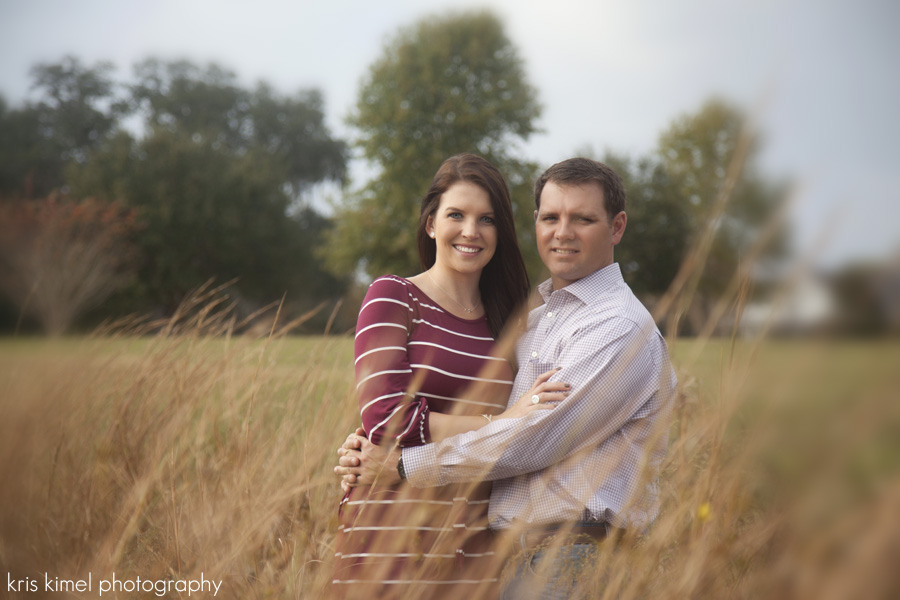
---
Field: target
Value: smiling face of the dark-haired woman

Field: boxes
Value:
[426,181,497,273]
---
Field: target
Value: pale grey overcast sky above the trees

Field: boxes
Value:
[0,0,900,267]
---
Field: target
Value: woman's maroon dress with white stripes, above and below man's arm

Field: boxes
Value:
[332,275,512,598]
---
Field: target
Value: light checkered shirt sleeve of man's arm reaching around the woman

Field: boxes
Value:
[403,318,671,487]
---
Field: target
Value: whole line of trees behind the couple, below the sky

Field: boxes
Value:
[0,12,783,332]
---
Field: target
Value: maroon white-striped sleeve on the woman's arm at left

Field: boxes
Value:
[354,277,431,447]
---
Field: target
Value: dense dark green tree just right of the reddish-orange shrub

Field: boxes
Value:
[70,130,341,312]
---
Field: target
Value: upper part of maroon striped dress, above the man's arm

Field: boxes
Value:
[355,275,512,447]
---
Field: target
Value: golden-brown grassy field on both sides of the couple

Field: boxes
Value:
[0,329,900,599]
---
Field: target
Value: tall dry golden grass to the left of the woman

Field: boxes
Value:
[0,284,357,598]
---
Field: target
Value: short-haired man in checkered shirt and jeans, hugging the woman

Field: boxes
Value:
[335,158,676,598]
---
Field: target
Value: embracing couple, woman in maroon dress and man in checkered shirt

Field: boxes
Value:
[332,154,676,599]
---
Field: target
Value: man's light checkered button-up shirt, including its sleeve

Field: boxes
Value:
[403,263,676,529]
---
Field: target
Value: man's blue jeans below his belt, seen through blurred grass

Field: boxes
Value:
[500,543,599,600]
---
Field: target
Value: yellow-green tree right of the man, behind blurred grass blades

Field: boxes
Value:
[659,98,787,332]
